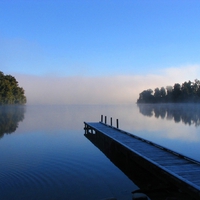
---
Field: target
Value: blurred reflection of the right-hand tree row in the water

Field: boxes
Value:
[138,104,200,126]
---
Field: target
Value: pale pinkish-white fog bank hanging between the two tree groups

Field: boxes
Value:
[14,66,200,105]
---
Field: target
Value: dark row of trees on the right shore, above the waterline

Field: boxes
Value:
[137,79,200,104]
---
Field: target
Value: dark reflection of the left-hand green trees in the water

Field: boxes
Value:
[0,106,25,138]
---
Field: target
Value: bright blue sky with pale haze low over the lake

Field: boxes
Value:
[0,0,200,103]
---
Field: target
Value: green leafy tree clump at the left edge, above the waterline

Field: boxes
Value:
[0,71,26,105]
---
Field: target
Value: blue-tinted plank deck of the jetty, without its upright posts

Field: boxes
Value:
[84,122,200,199]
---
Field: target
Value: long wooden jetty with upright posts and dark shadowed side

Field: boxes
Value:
[84,118,200,200]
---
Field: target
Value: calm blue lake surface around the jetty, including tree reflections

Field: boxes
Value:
[0,104,200,200]
